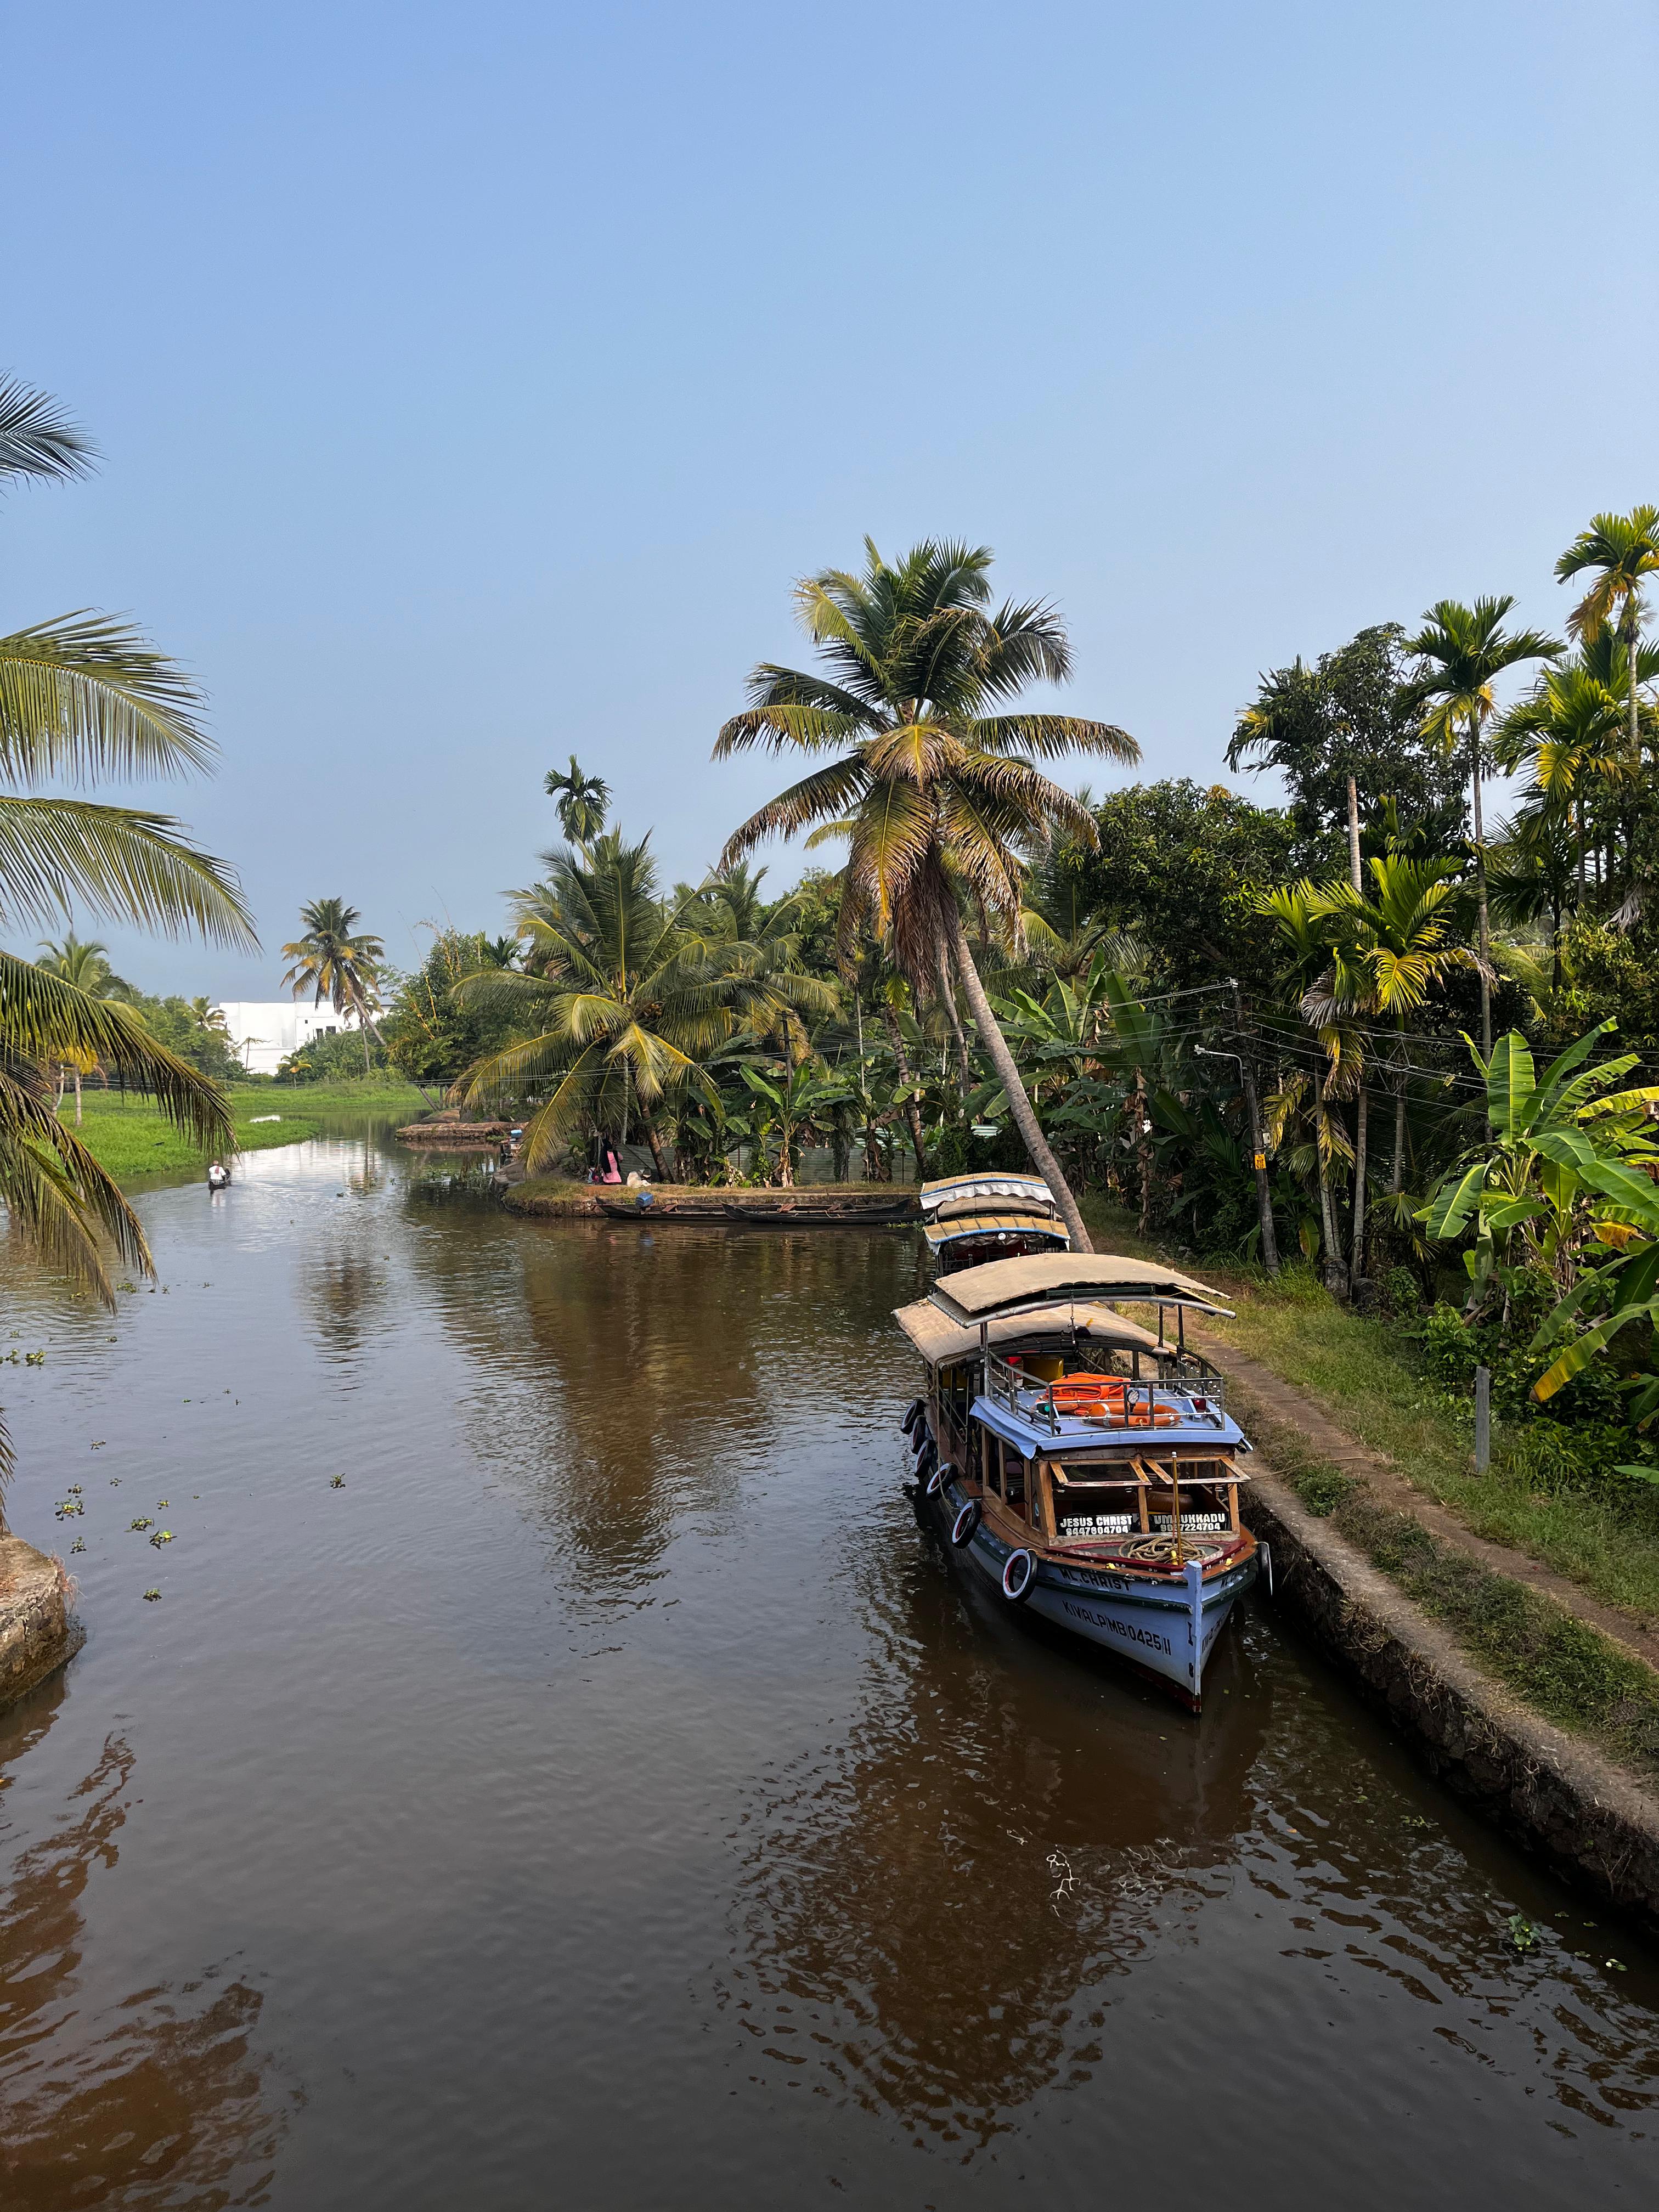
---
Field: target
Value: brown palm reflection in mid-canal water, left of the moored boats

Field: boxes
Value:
[416,1223,916,1604]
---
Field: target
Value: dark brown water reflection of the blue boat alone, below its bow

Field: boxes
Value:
[723,1513,1267,2146]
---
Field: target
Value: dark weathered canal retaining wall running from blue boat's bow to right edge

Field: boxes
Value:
[1245,1460,1659,1929]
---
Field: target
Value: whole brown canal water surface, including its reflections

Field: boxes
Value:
[0,1137,1659,2212]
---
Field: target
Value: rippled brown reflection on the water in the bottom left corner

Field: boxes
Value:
[0,1677,283,2212]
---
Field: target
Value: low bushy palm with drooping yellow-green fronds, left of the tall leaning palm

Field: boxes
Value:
[456,830,838,1181]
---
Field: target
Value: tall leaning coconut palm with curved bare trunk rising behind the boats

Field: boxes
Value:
[714,540,1139,1252]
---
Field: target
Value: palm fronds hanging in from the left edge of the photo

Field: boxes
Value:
[0,378,257,1471]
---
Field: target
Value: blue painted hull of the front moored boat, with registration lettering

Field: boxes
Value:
[934,1482,1256,1712]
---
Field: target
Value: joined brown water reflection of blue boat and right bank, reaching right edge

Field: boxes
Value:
[716,1513,1659,2157]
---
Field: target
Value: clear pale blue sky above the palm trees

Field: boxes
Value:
[0,0,1659,995]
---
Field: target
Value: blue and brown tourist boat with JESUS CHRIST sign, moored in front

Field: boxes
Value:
[896,1252,1256,1712]
